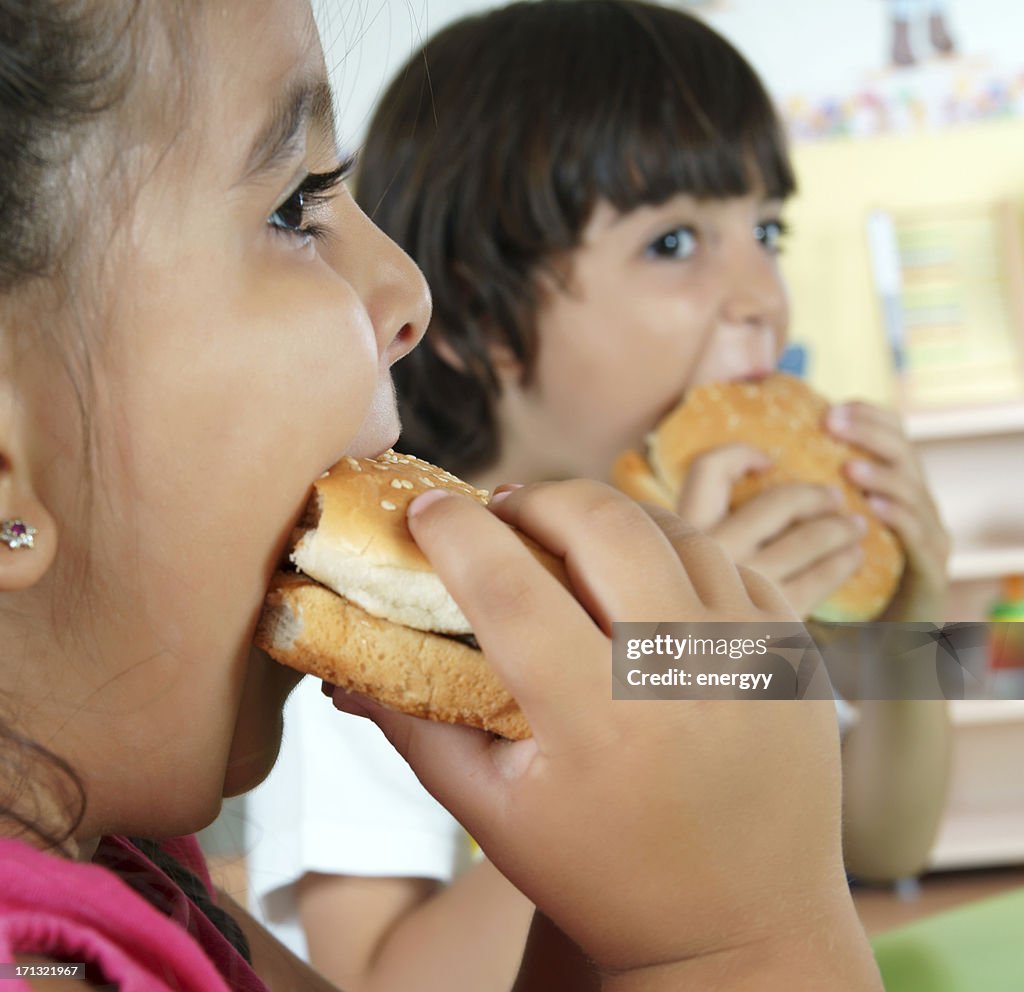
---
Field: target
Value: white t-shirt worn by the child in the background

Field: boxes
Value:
[246,678,471,958]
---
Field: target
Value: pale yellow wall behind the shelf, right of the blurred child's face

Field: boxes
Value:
[783,120,1024,403]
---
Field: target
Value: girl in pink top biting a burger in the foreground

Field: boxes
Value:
[0,0,879,992]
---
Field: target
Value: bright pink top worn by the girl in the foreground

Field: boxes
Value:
[0,837,266,992]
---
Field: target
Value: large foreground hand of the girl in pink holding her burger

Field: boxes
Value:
[335,481,871,989]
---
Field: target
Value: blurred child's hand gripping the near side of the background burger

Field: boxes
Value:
[678,444,863,616]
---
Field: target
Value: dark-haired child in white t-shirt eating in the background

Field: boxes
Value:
[250,0,949,990]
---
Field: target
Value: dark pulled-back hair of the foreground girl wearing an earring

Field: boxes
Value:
[0,0,249,959]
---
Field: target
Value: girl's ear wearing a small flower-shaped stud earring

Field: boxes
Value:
[0,386,57,593]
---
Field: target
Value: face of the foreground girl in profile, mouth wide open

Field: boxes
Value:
[18,0,429,834]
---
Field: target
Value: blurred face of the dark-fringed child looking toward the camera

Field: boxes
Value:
[491,195,787,481]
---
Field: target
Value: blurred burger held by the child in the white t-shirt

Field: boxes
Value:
[612,374,904,621]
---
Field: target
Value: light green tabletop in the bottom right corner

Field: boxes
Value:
[871,889,1024,992]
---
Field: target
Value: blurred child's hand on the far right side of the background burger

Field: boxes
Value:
[827,402,949,622]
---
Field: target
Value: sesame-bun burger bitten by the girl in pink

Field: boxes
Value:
[256,450,567,740]
